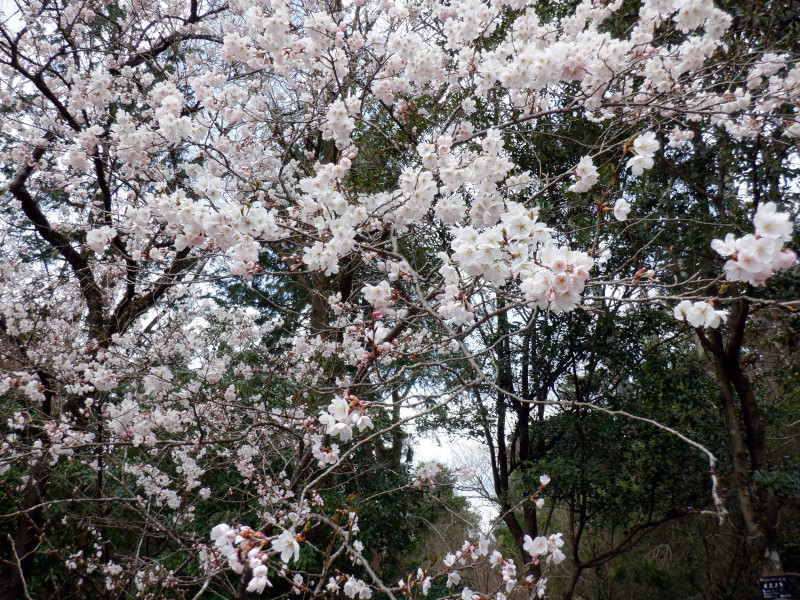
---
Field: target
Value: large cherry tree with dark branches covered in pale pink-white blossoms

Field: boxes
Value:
[0,0,800,600]
